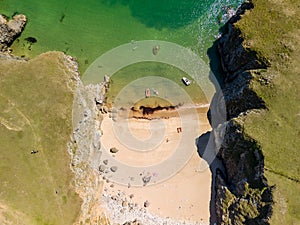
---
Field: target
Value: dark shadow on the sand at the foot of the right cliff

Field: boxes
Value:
[196,132,224,225]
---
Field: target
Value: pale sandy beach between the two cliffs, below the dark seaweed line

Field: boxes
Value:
[101,108,211,224]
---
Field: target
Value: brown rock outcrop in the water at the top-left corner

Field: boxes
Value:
[0,14,27,51]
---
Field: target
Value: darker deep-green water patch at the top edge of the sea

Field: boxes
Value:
[102,0,209,30]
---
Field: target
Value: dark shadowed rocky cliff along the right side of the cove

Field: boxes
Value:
[209,2,273,225]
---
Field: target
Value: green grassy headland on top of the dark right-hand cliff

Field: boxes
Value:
[236,0,300,225]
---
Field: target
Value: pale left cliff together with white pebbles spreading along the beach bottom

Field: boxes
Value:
[67,67,210,225]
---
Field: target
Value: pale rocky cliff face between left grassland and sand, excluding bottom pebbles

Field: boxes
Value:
[66,72,108,221]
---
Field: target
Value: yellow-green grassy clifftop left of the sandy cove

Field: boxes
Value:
[0,53,81,225]
